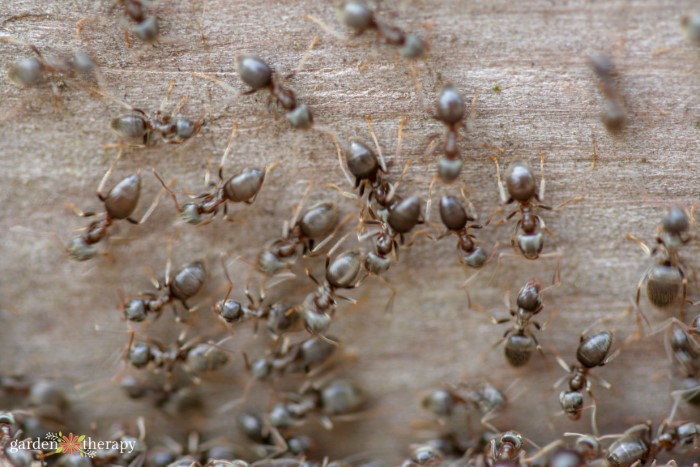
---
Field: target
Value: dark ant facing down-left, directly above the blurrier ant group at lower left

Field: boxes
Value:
[122,247,207,322]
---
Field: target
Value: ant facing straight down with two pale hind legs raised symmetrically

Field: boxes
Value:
[491,152,583,260]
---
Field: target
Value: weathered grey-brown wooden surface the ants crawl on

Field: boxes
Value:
[0,0,700,465]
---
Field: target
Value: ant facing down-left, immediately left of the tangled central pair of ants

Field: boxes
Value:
[257,184,343,276]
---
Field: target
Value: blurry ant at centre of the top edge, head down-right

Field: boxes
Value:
[306,0,426,58]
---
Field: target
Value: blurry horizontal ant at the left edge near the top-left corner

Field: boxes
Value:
[0,36,97,112]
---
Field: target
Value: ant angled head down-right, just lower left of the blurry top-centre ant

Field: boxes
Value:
[195,37,318,129]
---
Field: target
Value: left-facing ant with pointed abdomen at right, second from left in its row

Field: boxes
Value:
[153,123,277,224]
